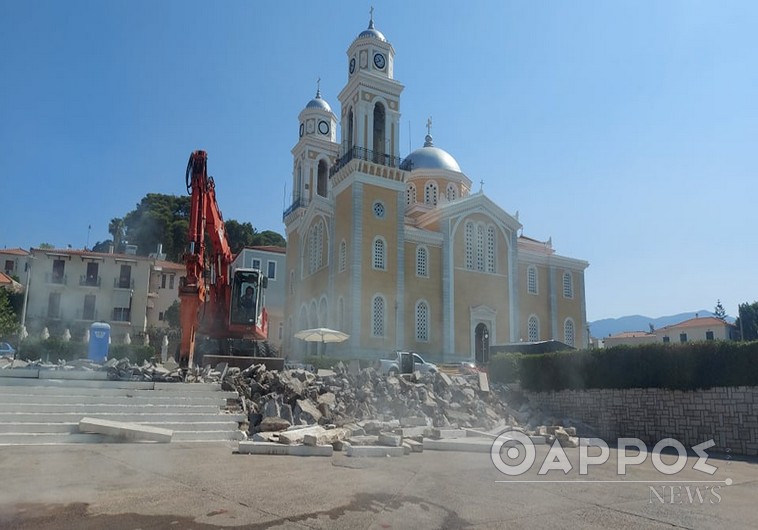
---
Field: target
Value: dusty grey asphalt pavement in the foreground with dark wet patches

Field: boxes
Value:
[0,442,758,530]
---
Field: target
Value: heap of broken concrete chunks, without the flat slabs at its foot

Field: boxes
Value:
[232,363,523,432]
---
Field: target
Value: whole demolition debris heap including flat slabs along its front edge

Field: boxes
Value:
[223,363,584,456]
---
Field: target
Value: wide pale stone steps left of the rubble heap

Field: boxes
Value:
[0,370,247,446]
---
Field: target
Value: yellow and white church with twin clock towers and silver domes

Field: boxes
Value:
[282,17,589,362]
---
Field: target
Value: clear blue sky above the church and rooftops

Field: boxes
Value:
[0,0,758,320]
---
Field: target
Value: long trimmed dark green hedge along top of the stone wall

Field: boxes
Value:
[490,341,758,391]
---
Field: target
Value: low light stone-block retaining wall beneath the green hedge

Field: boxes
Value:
[526,386,758,455]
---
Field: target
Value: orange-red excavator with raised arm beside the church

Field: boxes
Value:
[179,151,284,369]
